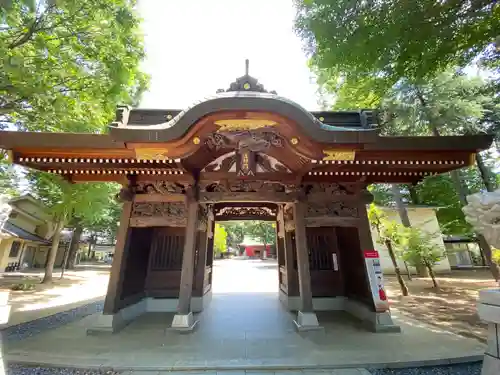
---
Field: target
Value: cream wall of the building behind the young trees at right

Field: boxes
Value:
[372,207,451,275]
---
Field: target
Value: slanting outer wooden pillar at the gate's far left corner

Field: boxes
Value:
[103,201,132,315]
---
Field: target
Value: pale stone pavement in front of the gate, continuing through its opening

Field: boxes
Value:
[1,260,484,375]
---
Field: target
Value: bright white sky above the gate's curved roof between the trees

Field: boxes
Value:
[138,0,319,110]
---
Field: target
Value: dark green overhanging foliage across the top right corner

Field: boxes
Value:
[296,0,500,87]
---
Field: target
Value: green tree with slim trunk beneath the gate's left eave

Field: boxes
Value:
[27,172,116,283]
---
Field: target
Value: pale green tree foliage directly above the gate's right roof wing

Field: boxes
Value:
[381,70,494,135]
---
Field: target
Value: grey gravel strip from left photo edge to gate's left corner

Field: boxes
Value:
[1,301,104,342]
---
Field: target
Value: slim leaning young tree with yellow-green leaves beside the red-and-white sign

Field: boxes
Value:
[368,203,409,296]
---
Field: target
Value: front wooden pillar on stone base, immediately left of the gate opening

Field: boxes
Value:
[172,197,198,331]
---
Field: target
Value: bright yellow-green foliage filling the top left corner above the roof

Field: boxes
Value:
[0,0,148,132]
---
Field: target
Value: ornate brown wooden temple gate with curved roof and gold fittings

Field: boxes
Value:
[0,62,492,332]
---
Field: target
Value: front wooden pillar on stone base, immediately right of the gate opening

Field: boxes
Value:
[293,201,321,331]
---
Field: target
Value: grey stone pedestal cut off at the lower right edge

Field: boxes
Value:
[477,289,500,375]
